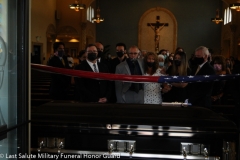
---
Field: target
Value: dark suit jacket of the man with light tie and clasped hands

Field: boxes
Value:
[75,60,111,102]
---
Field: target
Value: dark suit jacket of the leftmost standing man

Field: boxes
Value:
[48,56,71,99]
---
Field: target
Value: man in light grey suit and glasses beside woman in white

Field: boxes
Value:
[115,46,144,104]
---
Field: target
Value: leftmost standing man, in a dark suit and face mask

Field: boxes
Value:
[48,42,71,100]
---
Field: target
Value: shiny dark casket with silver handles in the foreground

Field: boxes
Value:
[31,101,238,160]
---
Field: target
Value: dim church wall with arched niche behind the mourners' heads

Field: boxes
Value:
[29,0,240,64]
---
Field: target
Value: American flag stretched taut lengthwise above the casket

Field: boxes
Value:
[31,64,240,83]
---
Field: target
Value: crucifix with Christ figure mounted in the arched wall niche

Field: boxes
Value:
[147,16,168,52]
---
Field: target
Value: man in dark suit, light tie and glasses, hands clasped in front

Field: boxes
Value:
[75,44,111,103]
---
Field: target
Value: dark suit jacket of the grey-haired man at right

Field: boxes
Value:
[187,62,215,108]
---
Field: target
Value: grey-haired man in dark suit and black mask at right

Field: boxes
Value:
[188,46,215,108]
